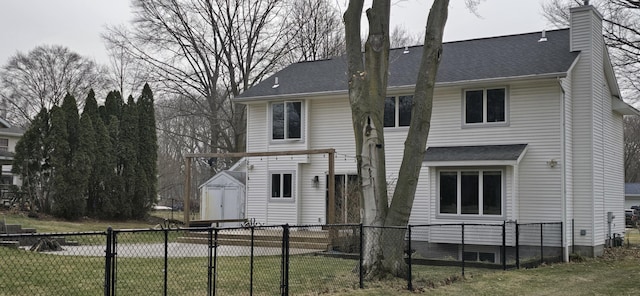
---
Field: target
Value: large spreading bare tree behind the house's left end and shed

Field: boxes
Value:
[103,0,288,156]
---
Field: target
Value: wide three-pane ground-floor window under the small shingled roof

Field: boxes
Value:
[439,169,503,216]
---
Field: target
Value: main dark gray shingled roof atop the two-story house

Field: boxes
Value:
[236,29,578,102]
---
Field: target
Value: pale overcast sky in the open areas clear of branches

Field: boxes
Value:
[0,0,551,65]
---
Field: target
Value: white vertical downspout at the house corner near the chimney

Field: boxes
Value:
[558,77,574,262]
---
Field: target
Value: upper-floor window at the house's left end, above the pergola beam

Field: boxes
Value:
[271,102,302,140]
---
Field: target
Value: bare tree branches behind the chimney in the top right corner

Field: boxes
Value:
[543,0,640,101]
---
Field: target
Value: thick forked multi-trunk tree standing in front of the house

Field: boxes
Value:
[344,0,449,278]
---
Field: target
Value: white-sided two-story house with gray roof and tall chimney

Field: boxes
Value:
[235,5,638,260]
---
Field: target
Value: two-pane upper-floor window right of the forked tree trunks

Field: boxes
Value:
[464,88,507,125]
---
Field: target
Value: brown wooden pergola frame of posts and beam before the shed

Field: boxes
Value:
[184,148,336,226]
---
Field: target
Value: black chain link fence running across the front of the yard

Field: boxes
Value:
[0,222,562,295]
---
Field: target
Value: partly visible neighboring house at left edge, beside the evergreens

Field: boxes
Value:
[0,118,24,198]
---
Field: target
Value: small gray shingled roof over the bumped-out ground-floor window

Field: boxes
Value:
[424,144,527,161]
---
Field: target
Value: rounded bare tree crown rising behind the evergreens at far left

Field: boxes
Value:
[0,45,106,126]
